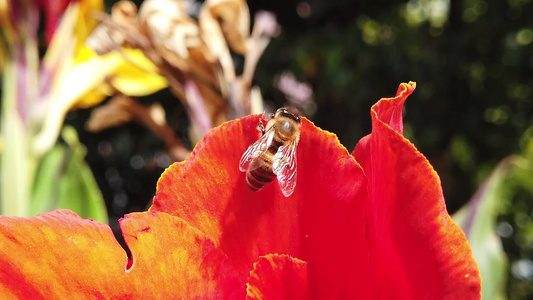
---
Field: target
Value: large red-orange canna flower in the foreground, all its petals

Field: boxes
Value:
[0,83,481,299]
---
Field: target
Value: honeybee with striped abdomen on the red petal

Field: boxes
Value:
[239,107,301,197]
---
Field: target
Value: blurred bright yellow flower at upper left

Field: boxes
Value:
[33,0,167,154]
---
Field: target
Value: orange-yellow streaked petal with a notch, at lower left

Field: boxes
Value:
[0,210,244,299]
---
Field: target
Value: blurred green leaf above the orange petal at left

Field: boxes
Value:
[31,127,108,223]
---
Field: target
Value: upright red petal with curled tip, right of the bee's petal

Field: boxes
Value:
[353,83,480,299]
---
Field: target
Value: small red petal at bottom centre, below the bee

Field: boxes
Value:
[246,254,309,300]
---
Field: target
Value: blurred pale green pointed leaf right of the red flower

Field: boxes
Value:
[453,159,511,300]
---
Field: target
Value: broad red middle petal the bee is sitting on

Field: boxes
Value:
[151,115,372,297]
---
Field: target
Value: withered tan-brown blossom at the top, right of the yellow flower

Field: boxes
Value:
[87,0,237,134]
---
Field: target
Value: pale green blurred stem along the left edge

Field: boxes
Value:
[0,29,39,216]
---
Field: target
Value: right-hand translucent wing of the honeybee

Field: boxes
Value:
[272,139,299,197]
